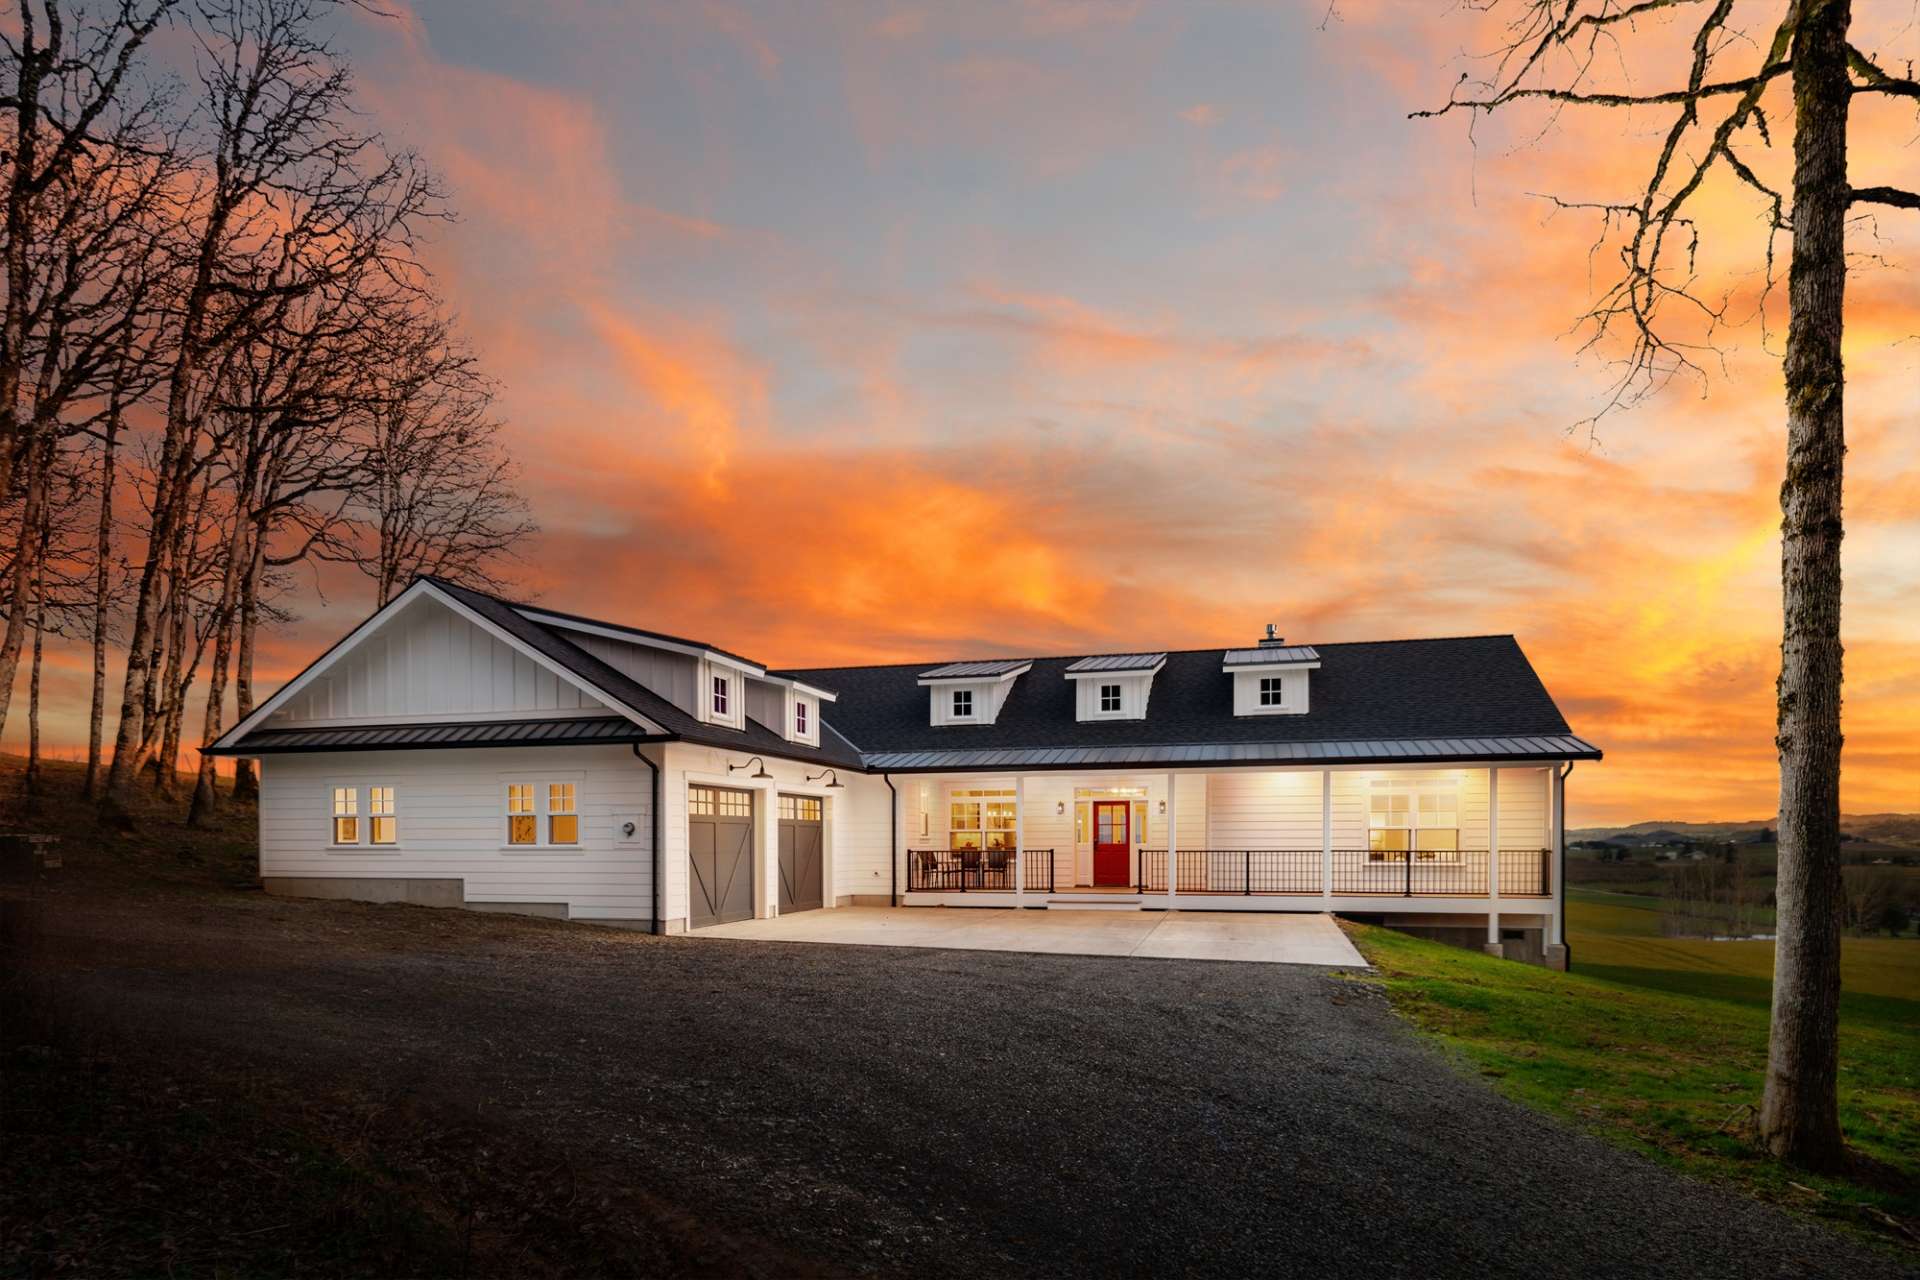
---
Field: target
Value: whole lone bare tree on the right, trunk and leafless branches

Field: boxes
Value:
[1415,0,1920,1167]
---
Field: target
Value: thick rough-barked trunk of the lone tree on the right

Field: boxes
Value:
[1761,0,1851,1167]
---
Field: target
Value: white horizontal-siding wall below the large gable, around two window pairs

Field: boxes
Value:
[259,747,653,921]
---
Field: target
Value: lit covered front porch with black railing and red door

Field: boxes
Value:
[899,764,1563,946]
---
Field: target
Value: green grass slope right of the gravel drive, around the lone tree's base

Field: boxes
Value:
[1348,890,1920,1249]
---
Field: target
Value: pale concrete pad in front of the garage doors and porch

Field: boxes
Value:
[687,906,1367,969]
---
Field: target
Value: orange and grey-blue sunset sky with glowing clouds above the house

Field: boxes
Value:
[8,0,1920,823]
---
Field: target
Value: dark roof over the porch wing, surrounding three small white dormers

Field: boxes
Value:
[793,635,1599,768]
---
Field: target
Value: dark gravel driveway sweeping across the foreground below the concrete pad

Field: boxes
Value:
[30,896,1899,1280]
